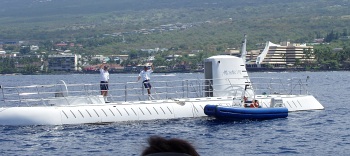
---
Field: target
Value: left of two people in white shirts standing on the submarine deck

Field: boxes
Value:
[100,62,109,103]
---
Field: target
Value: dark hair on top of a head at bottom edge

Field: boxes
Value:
[141,136,199,156]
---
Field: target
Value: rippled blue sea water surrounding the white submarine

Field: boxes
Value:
[0,72,350,156]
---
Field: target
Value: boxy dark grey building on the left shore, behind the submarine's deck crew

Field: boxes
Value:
[48,54,81,71]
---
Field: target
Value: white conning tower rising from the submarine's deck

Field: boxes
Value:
[204,55,251,97]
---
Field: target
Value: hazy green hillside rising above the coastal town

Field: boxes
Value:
[0,0,350,53]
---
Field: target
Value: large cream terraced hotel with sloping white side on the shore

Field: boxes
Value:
[255,42,315,68]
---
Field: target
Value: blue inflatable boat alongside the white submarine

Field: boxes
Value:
[204,105,288,120]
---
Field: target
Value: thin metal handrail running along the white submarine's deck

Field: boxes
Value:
[0,78,308,107]
